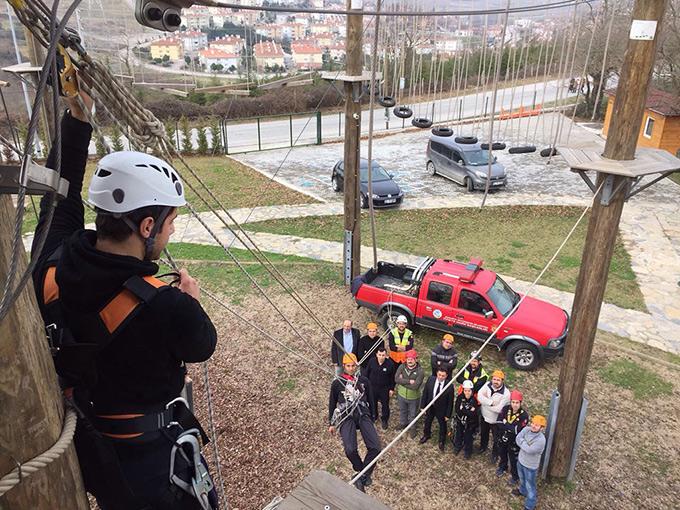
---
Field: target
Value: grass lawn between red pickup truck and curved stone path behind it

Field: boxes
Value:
[246,206,646,311]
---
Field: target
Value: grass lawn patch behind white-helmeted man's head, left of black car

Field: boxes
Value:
[23,156,315,234]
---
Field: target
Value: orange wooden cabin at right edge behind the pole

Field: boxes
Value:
[602,88,680,157]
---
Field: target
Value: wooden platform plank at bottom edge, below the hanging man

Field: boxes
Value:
[279,470,390,510]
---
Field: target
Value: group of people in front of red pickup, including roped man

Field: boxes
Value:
[329,316,546,510]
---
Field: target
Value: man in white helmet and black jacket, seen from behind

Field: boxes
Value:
[32,89,217,510]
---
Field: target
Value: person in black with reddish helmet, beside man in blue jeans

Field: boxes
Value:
[496,390,529,485]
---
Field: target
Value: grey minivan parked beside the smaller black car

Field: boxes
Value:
[427,135,508,191]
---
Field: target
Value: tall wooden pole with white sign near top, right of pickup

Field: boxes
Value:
[549,0,667,478]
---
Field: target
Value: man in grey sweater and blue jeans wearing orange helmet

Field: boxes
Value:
[512,415,547,510]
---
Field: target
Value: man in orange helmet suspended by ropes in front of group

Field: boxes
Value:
[328,354,382,492]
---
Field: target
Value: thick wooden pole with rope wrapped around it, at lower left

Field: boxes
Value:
[0,195,89,510]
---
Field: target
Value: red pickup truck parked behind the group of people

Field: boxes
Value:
[352,257,569,370]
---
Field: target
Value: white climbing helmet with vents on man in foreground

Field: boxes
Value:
[88,151,186,214]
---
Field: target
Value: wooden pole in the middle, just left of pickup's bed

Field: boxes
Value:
[344,0,370,278]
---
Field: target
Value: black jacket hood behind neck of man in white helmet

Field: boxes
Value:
[57,230,158,312]
